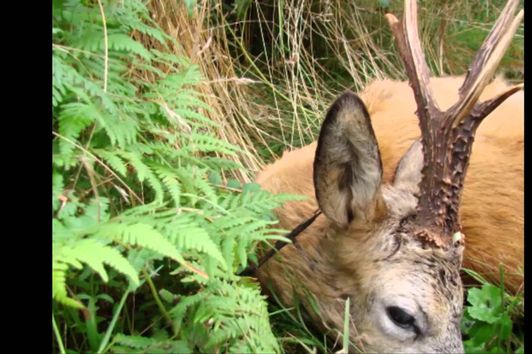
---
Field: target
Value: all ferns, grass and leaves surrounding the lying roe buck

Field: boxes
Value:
[52,0,524,353]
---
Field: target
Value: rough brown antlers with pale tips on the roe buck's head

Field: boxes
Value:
[386,0,523,247]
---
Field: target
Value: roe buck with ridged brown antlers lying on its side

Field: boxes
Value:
[252,0,524,353]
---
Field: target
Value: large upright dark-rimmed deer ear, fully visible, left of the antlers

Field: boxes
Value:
[314,92,382,226]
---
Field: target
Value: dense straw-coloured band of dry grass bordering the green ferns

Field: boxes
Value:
[143,0,263,182]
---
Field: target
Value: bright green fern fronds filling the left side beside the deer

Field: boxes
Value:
[53,1,302,353]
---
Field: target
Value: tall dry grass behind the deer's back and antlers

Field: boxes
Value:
[143,0,523,177]
